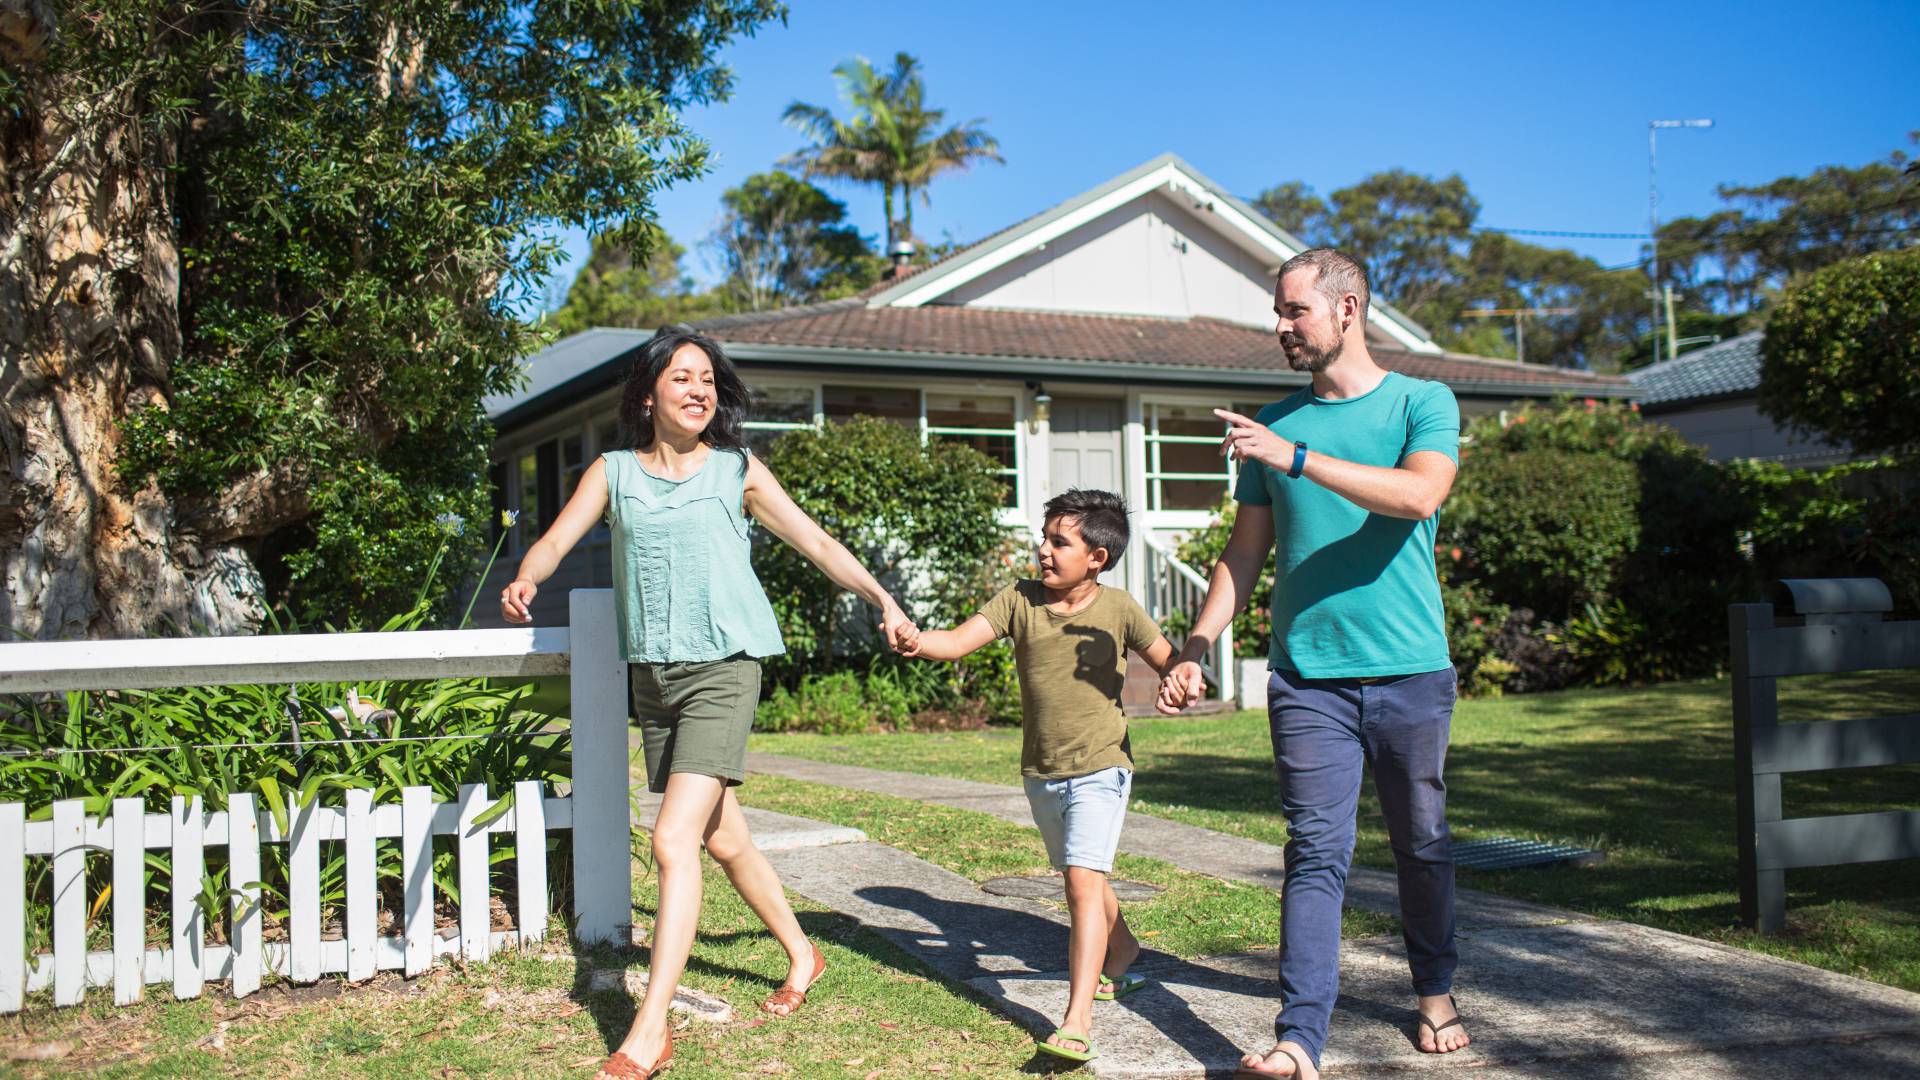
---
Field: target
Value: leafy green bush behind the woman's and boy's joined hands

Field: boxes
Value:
[755,417,1008,678]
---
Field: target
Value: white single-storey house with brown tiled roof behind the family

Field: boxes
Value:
[480,154,1634,672]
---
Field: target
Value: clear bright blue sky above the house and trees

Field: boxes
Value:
[537,0,1920,303]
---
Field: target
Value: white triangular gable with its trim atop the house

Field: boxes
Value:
[872,154,1440,352]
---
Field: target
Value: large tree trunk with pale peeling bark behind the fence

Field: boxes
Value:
[0,0,266,640]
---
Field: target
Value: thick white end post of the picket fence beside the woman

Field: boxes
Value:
[568,588,634,945]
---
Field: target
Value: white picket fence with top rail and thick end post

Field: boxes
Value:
[0,590,634,1013]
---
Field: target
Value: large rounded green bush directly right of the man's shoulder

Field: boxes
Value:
[1440,402,1753,682]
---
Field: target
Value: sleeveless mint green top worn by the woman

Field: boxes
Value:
[601,448,787,663]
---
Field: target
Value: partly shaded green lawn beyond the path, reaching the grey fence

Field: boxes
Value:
[753,673,1920,990]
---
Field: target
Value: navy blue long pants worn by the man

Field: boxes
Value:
[1267,667,1457,1067]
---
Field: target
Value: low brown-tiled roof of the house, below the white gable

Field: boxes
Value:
[486,298,1634,427]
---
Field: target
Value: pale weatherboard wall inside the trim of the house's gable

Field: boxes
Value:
[939,190,1277,327]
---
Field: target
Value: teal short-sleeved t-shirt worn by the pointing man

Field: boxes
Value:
[1233,373,1459,678]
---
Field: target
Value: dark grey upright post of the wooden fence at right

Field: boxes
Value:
[1726,603,1788,934]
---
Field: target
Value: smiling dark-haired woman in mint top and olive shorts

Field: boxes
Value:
[499,327,914,1080]
